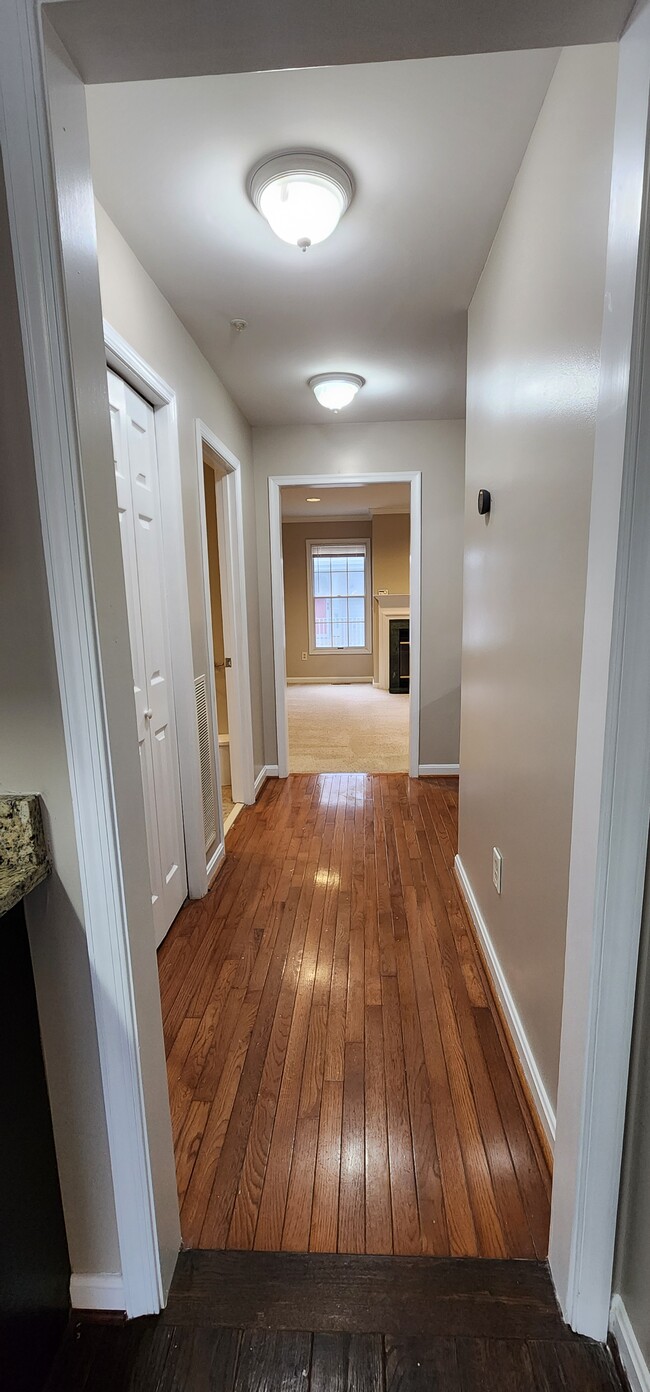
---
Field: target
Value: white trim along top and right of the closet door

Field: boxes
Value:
[104,319,207,899]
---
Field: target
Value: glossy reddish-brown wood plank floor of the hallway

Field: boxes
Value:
[160,774,550,1257]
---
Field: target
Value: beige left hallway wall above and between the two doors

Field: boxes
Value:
[97,205,264,773]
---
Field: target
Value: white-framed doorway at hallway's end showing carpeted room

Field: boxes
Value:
[270,473,420,777]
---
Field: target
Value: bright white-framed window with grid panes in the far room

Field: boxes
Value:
[308,541,372,653]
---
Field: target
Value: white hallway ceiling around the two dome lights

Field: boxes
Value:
[88,49,557,425]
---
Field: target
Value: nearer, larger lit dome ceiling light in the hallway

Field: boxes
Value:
[248,150,354,252]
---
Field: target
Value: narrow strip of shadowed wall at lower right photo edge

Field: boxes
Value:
[614,840,650,1366]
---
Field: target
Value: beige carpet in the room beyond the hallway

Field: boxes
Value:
[287,682,409,774]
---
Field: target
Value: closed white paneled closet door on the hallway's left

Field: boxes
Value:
[109,372,188,947]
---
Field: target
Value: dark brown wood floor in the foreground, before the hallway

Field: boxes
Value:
[47,1251,622,1392]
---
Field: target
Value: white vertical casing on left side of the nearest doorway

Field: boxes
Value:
[0,0,164,1315]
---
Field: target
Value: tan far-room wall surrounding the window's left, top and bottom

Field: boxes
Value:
[283,522,373,682]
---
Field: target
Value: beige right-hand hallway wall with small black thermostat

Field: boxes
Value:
[459,45,617,1104]
